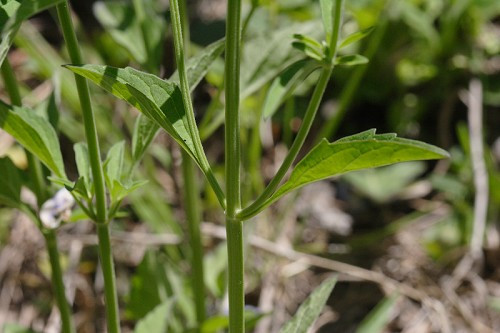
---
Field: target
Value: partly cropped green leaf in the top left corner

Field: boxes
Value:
[0,0,64,65]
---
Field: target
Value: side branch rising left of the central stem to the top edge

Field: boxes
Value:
[170,0,226,209]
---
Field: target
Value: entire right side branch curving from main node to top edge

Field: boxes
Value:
[236,0,344,220]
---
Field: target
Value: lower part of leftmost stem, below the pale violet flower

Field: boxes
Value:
[43,229,75,333]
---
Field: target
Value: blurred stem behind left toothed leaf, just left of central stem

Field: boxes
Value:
[182,150,206,327]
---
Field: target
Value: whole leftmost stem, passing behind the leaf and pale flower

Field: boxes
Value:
[1,58,75,333]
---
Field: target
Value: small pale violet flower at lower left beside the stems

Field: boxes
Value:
[40,188,75,229]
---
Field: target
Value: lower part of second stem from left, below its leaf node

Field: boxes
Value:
[96,223,120,333]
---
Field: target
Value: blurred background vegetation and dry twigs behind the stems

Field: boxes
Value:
[0,0,500,333]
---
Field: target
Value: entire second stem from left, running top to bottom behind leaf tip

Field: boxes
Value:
[57,1,120,333]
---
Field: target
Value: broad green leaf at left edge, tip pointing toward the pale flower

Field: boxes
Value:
[0,101,67,178]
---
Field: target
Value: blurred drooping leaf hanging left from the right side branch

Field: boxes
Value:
[262,59,317,119]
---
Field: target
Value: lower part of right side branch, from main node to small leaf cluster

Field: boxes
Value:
[238,67,332,220]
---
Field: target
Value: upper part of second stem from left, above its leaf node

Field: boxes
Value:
[57,0,107,223]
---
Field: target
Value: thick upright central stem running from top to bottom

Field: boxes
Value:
[224,0,245,333]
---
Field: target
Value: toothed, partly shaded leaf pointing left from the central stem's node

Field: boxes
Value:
[66,65,199,163]
